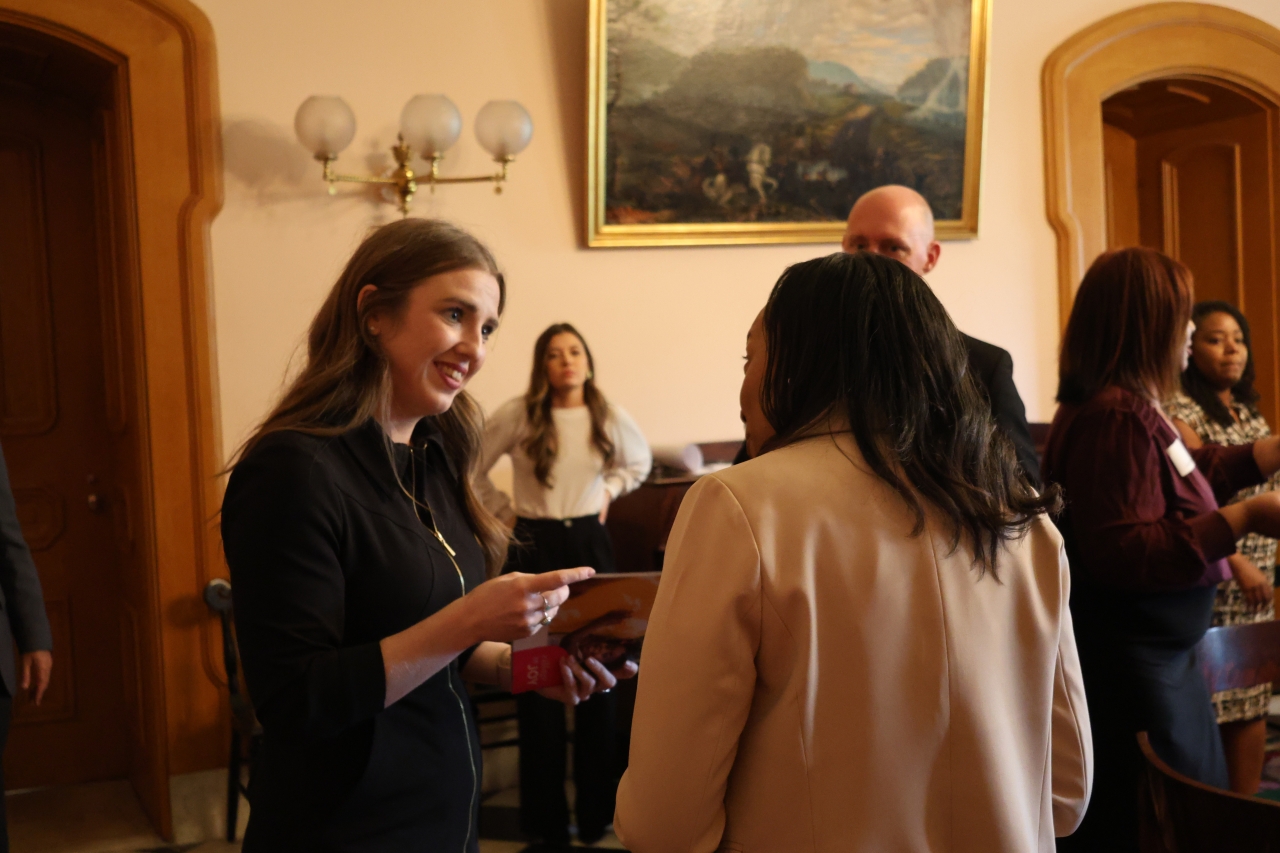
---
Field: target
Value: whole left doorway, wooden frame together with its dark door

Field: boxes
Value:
[0,0,228,836]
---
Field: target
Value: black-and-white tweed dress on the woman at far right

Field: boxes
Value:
[1165,392,1280,722]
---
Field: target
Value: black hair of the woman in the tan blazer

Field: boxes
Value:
[760,252,1061,579]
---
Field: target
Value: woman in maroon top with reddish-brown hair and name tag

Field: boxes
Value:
[1044,242,1280,853]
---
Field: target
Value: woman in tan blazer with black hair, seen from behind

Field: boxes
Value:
[614,255,1092,853]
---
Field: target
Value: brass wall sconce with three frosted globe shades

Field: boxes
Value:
[293,95,534,216]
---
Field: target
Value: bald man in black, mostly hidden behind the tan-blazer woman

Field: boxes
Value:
[842,186,1039,488]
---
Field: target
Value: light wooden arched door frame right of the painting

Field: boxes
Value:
[1041,3,1280,329]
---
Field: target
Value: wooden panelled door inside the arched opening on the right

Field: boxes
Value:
[1137,109,1280,429]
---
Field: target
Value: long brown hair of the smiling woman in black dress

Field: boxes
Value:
[233,219,509,575]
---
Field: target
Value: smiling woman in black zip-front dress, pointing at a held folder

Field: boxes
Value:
[223,219,632,853]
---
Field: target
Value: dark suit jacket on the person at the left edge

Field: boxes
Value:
[0,440,54,695]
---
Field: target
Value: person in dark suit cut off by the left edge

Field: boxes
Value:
[0,438,54,853]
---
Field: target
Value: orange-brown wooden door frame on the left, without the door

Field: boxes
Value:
[0,0,222,839]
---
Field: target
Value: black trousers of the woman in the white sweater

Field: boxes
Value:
[507,516,618,843]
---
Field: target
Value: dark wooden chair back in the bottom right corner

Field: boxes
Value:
[1138,731,1280,853]
